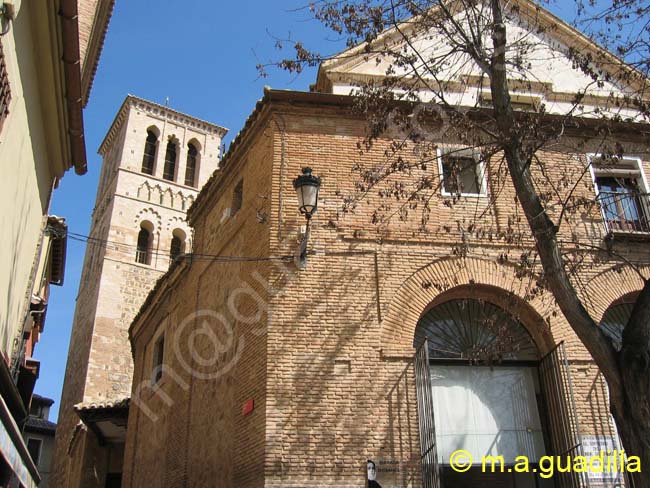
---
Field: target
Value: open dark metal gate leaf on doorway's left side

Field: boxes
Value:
[413,340,440,488]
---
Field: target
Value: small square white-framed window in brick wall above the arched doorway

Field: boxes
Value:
[439,154,485,195]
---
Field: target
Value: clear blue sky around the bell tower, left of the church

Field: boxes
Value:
[35,0,584,421]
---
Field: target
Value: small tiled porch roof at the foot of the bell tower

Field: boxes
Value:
[74,398,130,445]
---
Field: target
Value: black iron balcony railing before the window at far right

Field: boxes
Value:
[598,190,650,233]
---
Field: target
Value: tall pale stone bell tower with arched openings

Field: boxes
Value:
[50,95,227,488]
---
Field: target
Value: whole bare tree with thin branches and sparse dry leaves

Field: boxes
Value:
[259,0,650,480]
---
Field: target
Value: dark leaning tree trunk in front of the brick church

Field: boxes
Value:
[488,0,650,488]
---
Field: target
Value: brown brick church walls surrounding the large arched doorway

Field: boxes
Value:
[123,87,650,487]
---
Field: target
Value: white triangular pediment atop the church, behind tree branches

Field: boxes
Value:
[316,0,648,118]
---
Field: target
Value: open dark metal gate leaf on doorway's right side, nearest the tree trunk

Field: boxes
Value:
[539,342,589,488]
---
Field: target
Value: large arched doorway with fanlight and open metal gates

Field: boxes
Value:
[414,297,579,488]
